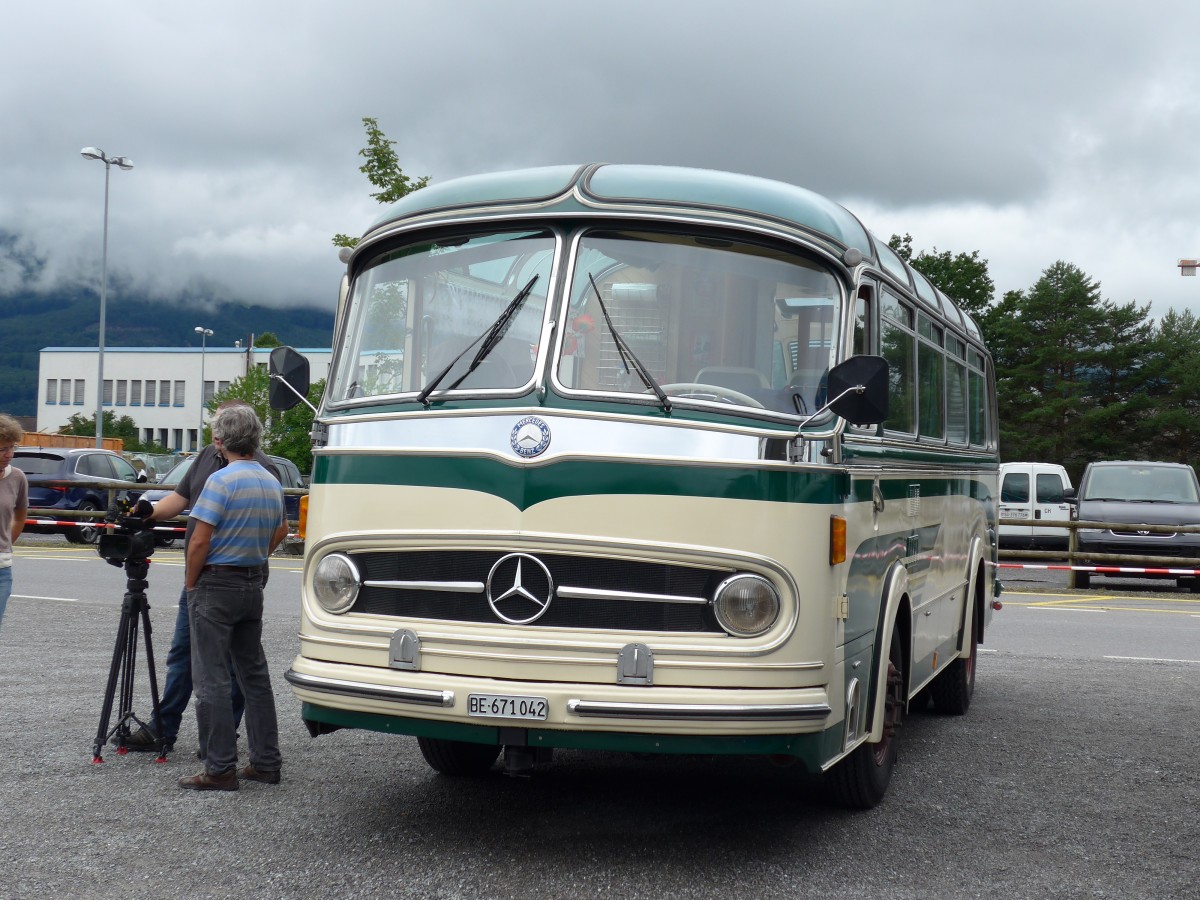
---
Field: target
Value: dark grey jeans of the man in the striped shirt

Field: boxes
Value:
[187,566,282,775]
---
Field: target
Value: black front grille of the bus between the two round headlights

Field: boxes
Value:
[350,551,731,634]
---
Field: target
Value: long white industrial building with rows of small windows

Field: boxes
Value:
[37,347,330,450]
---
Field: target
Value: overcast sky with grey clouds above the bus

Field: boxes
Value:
[0,0,1200,328]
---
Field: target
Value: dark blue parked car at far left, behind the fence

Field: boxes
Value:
[12,446,145,544]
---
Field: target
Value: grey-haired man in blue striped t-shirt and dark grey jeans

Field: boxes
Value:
[179,406,287,791]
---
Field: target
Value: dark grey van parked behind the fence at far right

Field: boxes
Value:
[1075,462,1200,592]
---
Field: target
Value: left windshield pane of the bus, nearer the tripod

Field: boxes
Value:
[330,232,554,401]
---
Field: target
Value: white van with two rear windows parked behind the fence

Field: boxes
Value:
[1000,462,1075,550]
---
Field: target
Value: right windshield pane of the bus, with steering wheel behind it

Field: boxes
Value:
[557,230,841,415]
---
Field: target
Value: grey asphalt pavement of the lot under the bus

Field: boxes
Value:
[0,540,1200,900]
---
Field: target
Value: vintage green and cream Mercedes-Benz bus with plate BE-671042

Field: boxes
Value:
[272,164,998,806]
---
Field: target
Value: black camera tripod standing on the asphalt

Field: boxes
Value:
[91,558,167,764]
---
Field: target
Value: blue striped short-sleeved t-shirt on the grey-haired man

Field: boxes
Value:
[192,460,286,565]
